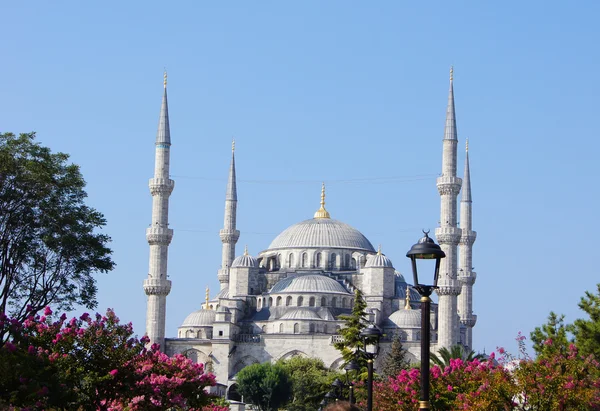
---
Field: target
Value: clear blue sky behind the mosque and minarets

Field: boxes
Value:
[0,1,600,358]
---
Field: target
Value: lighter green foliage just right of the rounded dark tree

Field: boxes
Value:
[278,356,342,411]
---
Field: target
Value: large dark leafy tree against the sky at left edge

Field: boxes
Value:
[0,133,114,341]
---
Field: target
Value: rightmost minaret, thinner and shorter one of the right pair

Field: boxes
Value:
[458,140,477,349]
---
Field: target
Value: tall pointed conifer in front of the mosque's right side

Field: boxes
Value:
[333,288,369,368]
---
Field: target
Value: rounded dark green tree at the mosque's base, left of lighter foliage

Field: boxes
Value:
[236,362,292,411]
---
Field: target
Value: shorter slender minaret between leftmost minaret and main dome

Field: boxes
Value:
[218,141,240,290]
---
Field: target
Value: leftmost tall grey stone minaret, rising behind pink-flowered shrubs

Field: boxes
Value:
[144,72,175,349]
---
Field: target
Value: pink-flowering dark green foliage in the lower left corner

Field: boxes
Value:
[0,307,216,411]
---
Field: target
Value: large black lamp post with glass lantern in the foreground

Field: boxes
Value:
[406,231,446,411]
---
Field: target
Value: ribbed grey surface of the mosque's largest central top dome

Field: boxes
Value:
[269,218,375,251]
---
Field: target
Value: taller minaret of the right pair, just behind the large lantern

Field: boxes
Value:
[435,68,461,349]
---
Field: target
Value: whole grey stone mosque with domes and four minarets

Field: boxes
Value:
[144,70,477,399]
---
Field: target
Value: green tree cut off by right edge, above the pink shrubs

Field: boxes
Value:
[567,284,600,360]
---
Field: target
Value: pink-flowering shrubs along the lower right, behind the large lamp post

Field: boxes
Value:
[357,335,600,411]
